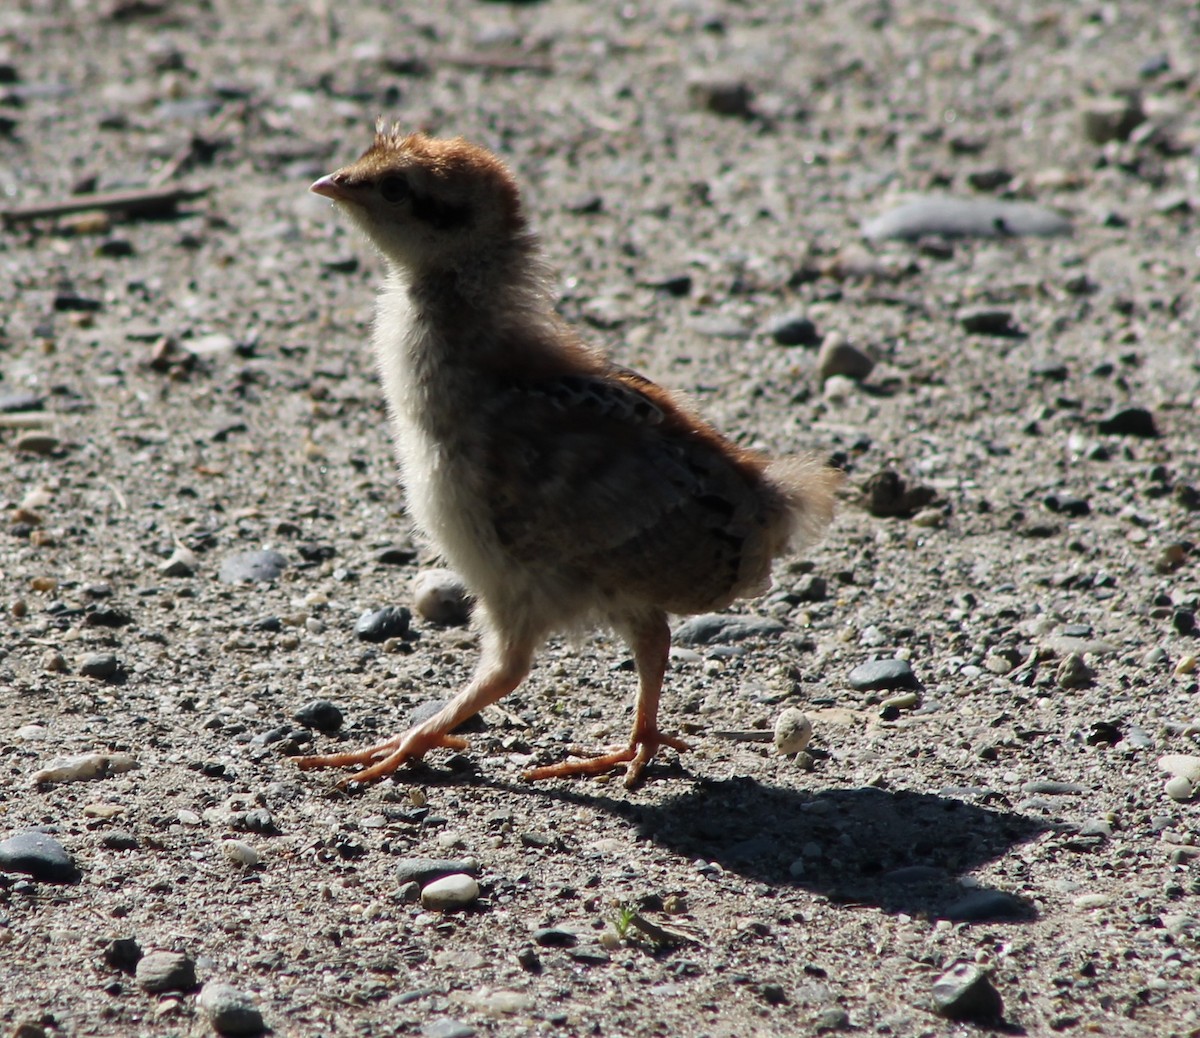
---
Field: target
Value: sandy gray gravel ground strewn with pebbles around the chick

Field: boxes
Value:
[0,0,1200,1038]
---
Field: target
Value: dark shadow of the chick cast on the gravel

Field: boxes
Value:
[523,778,1049,923]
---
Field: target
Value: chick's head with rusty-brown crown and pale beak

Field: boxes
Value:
[311,124,526,274]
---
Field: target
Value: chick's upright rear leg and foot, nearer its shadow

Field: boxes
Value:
[522,613,689,790]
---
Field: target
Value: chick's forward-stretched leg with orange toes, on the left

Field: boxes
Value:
[296,637,533,787]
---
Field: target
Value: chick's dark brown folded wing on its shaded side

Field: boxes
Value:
[487,370,778,612]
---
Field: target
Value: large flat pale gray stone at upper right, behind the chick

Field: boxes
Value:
[863,196,1070,241]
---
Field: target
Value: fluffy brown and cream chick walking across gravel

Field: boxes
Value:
[299,121,841,788]
